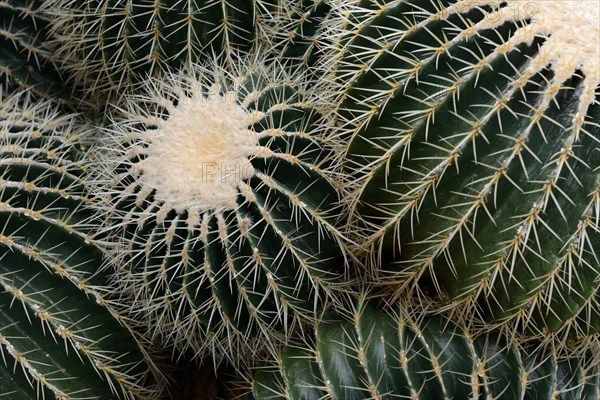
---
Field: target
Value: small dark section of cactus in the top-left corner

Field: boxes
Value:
[0,0,64,98]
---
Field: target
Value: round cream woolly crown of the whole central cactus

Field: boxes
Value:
[139,92,258,213]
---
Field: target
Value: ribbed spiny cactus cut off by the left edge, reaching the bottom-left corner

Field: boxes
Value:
[0,91,164,399]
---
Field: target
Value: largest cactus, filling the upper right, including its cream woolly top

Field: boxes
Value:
[336,0,600,337]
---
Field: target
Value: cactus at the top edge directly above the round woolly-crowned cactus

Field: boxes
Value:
[45,0,293,100]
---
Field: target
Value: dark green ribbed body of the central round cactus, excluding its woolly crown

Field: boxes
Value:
[107,68,346,362]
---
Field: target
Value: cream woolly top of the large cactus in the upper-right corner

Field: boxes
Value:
[448,0,600,130]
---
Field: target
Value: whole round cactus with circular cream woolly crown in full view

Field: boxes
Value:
[91,56,346,363]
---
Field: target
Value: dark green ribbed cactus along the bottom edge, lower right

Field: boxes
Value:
[250,302,600,400]
